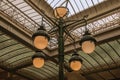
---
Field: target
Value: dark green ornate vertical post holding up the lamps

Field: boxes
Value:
[58,18,64,80]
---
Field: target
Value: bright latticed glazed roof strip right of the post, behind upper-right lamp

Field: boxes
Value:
[72,12,120,37]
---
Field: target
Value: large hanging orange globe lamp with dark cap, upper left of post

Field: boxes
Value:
[32,26,50,49]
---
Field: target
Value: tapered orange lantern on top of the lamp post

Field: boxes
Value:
[54,7,68,18]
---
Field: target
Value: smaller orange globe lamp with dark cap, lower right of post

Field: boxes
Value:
[69,54,82,71]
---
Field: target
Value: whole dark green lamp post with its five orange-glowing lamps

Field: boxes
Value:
[32,0,96,80]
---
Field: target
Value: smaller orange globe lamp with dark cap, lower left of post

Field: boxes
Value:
[32,51,45,68]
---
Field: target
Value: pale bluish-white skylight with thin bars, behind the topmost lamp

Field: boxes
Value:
[46,0,104,16]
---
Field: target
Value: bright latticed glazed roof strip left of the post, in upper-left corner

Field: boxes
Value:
[0,0,51,32]
